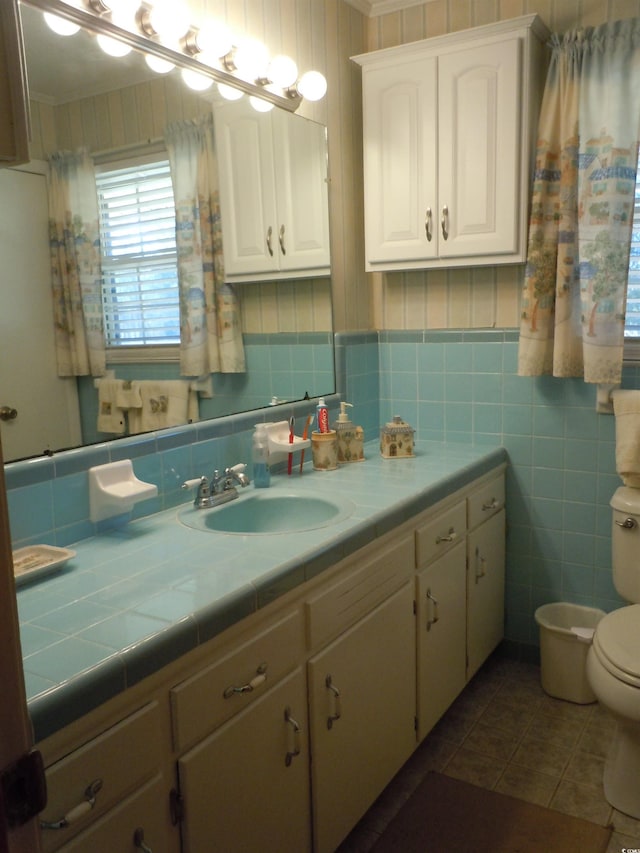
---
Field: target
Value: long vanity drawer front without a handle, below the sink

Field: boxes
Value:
[306,534,415,649]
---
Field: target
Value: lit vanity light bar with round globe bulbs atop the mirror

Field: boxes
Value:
[29,0,327,112]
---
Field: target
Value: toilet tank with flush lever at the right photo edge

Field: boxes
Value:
[611,486,640,604]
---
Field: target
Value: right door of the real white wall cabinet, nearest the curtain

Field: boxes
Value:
[438,37,522,258]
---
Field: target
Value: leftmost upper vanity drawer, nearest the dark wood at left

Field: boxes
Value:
[40,702,162,851]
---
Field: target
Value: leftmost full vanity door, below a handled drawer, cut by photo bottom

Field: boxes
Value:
[178,669,311,853]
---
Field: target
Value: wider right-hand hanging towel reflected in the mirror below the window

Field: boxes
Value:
[129,379,198,433]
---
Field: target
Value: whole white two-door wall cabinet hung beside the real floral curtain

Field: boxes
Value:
[354,16,547,271]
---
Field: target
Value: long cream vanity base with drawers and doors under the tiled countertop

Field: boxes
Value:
[39,469,504,853]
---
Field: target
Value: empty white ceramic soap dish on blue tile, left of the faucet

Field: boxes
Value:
[89,459,158,522]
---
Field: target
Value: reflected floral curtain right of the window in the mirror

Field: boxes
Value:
[165,115,246,376]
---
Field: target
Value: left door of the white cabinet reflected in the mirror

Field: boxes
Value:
[214,103,279,276]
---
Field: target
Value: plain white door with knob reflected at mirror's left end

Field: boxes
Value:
[0,166,81,461]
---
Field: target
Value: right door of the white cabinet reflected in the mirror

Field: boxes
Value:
[272,110,331,275]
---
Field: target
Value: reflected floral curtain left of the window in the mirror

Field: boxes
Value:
[48,151,105,376]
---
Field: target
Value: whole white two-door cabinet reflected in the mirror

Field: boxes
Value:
[214,99,330,282]
